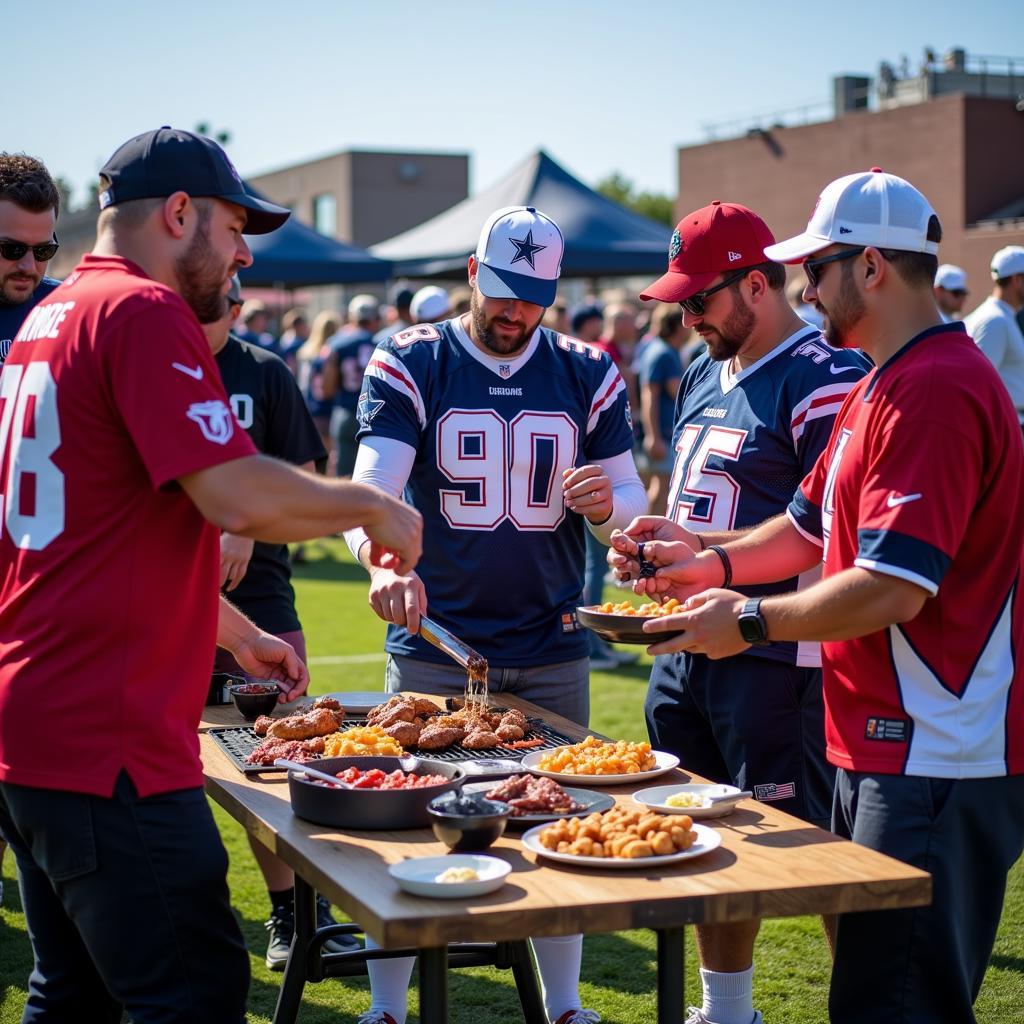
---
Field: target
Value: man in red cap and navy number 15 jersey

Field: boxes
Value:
[609,203,867,1024]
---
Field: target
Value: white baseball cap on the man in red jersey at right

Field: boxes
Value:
[765,167,939,263]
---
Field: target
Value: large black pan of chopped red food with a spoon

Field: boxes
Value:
[288,757,466,830]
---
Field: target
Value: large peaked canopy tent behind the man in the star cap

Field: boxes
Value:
[370,150,672,278]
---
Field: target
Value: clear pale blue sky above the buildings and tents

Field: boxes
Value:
[8,0,1024,211]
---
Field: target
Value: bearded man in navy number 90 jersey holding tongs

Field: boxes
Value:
[348,207,646,1024]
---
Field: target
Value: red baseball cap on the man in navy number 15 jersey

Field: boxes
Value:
[640,200,775,302]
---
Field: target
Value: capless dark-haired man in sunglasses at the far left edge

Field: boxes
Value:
[0,153,60,367]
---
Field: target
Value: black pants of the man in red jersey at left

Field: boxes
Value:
[0,773,249,1024]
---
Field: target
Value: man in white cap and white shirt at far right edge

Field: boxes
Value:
[964,246,1024,428]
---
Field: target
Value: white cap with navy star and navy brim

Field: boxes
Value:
[473,206,565,307]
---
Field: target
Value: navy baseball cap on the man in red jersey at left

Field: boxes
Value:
[99,125,291,234]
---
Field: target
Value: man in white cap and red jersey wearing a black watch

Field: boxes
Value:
[614,169,1024,1024]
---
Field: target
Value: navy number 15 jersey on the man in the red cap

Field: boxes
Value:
[666,328,868,666]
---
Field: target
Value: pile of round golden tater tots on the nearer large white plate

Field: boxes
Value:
[539,807,697,859]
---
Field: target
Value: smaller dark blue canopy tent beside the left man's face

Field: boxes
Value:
[239,185,392,289]
